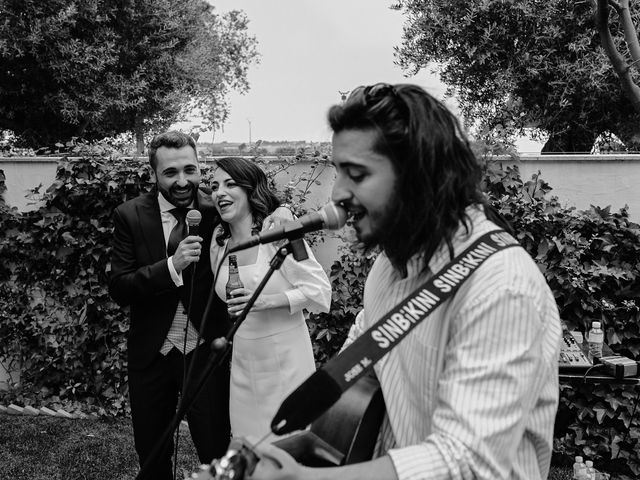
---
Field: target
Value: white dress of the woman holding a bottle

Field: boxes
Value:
[211,233,331,441]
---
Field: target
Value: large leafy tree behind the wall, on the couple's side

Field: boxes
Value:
[0,0,257,148]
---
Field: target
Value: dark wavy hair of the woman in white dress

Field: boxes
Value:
[215,157,280,246]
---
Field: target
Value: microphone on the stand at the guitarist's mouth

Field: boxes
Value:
[229,203,347,253]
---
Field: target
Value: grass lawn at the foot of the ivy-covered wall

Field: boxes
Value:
[0,415,572,480]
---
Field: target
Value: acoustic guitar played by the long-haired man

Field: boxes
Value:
[191,374,384,480]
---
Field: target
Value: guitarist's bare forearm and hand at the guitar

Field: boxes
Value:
[247,444,398,480]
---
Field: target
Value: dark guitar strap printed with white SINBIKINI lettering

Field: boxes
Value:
[271,230,520,434]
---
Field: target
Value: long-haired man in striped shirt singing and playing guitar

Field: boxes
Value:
[251,84,561,480]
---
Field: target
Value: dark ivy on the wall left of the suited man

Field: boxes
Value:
[0,146,156,413]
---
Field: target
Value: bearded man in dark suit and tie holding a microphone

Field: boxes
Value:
[109,131,230,480]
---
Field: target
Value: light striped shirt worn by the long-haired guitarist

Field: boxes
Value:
[347,207,561,480]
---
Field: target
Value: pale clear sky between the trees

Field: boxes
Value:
[177,0,540,151]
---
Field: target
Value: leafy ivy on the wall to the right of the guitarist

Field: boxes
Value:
[485,163,640,479]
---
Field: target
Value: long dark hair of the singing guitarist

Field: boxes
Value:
[328,84,500,276]
